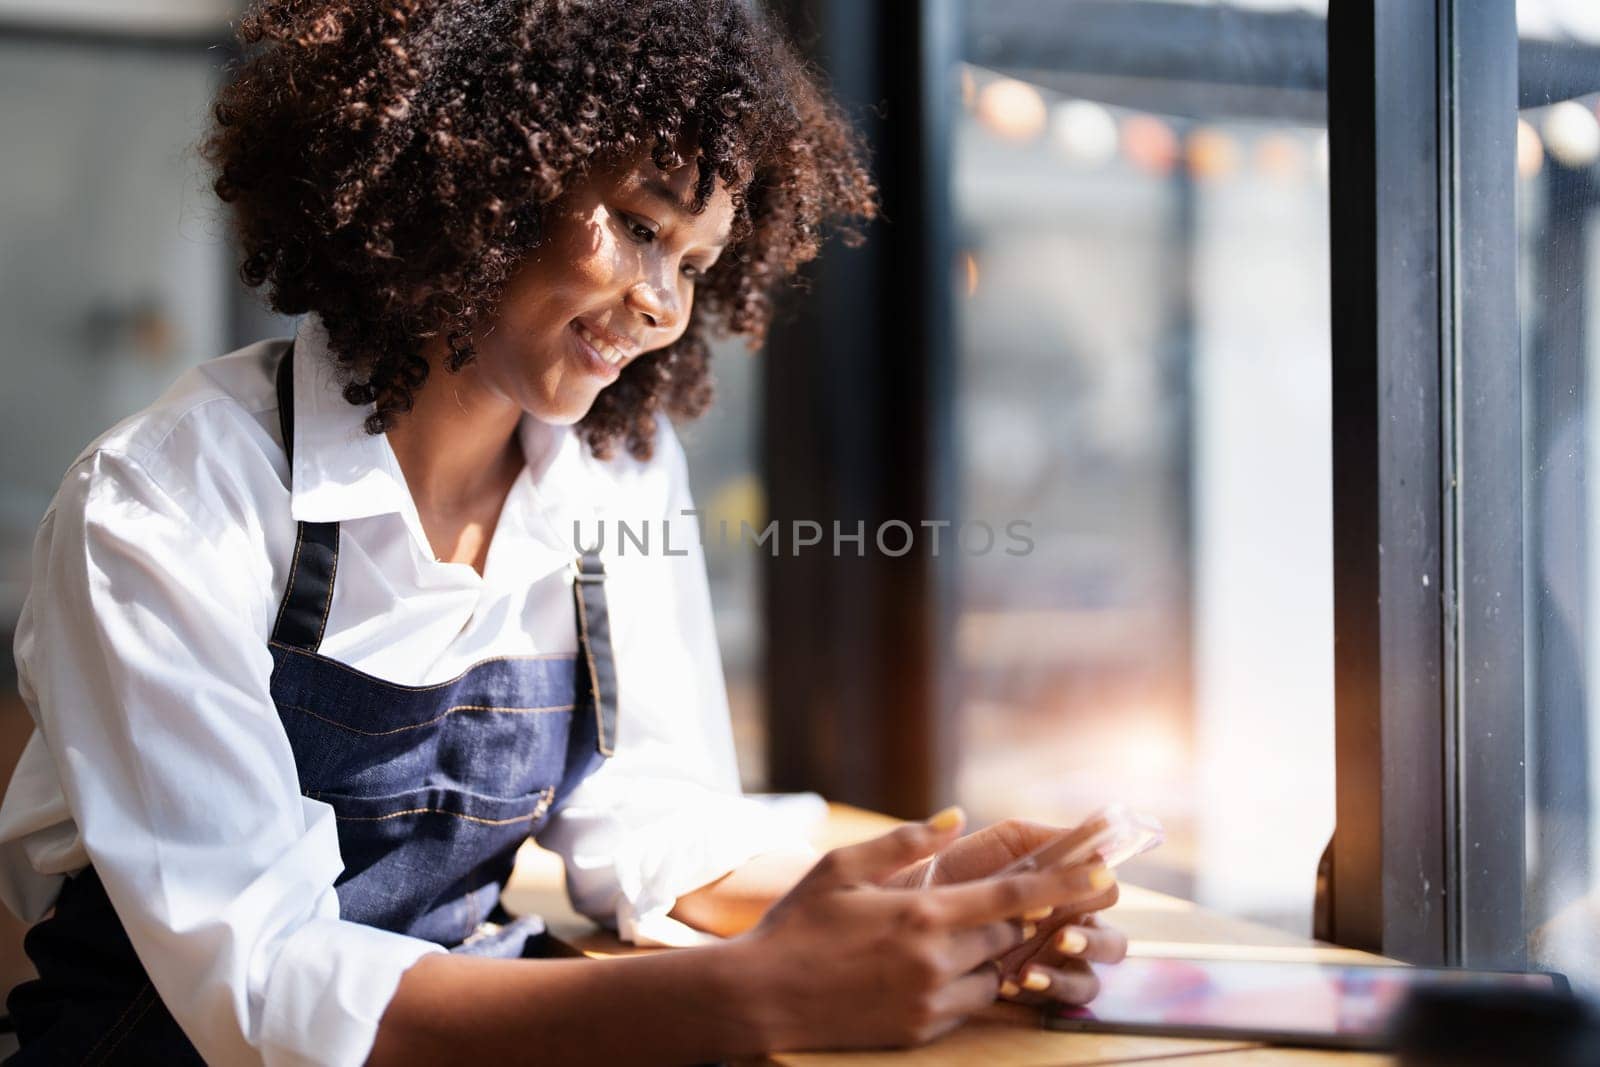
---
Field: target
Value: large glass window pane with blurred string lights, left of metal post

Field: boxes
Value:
[954,0,1333,933]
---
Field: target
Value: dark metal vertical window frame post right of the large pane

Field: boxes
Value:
[1328,0,1526,966]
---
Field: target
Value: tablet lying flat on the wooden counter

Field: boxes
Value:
[1045,957,1566,1049]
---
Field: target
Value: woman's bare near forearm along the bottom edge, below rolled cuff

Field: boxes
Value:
[366,944,770,1067]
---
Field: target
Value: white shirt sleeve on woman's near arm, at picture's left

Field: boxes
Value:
[5,453,440,1064]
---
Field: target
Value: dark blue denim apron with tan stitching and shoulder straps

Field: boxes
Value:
[6,346,616,1064]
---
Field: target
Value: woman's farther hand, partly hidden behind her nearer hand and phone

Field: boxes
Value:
[890,819,1128,1005]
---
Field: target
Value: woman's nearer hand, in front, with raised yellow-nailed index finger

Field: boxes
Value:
[728,816,1106,1049]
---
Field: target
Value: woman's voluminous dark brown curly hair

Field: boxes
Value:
[203,0,875,459]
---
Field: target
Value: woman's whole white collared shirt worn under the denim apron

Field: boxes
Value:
[0,320,803,1064]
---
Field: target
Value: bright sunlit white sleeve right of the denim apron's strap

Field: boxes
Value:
[539,419,813,944]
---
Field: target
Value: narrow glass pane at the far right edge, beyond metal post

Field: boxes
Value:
[1517,0,1600,989]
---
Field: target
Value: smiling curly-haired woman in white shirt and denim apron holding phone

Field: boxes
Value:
[0,0,1123,1064]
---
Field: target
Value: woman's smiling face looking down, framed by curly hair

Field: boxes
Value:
[469,155,733,424]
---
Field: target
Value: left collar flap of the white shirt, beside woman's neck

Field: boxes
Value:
[290,315,411,523]
